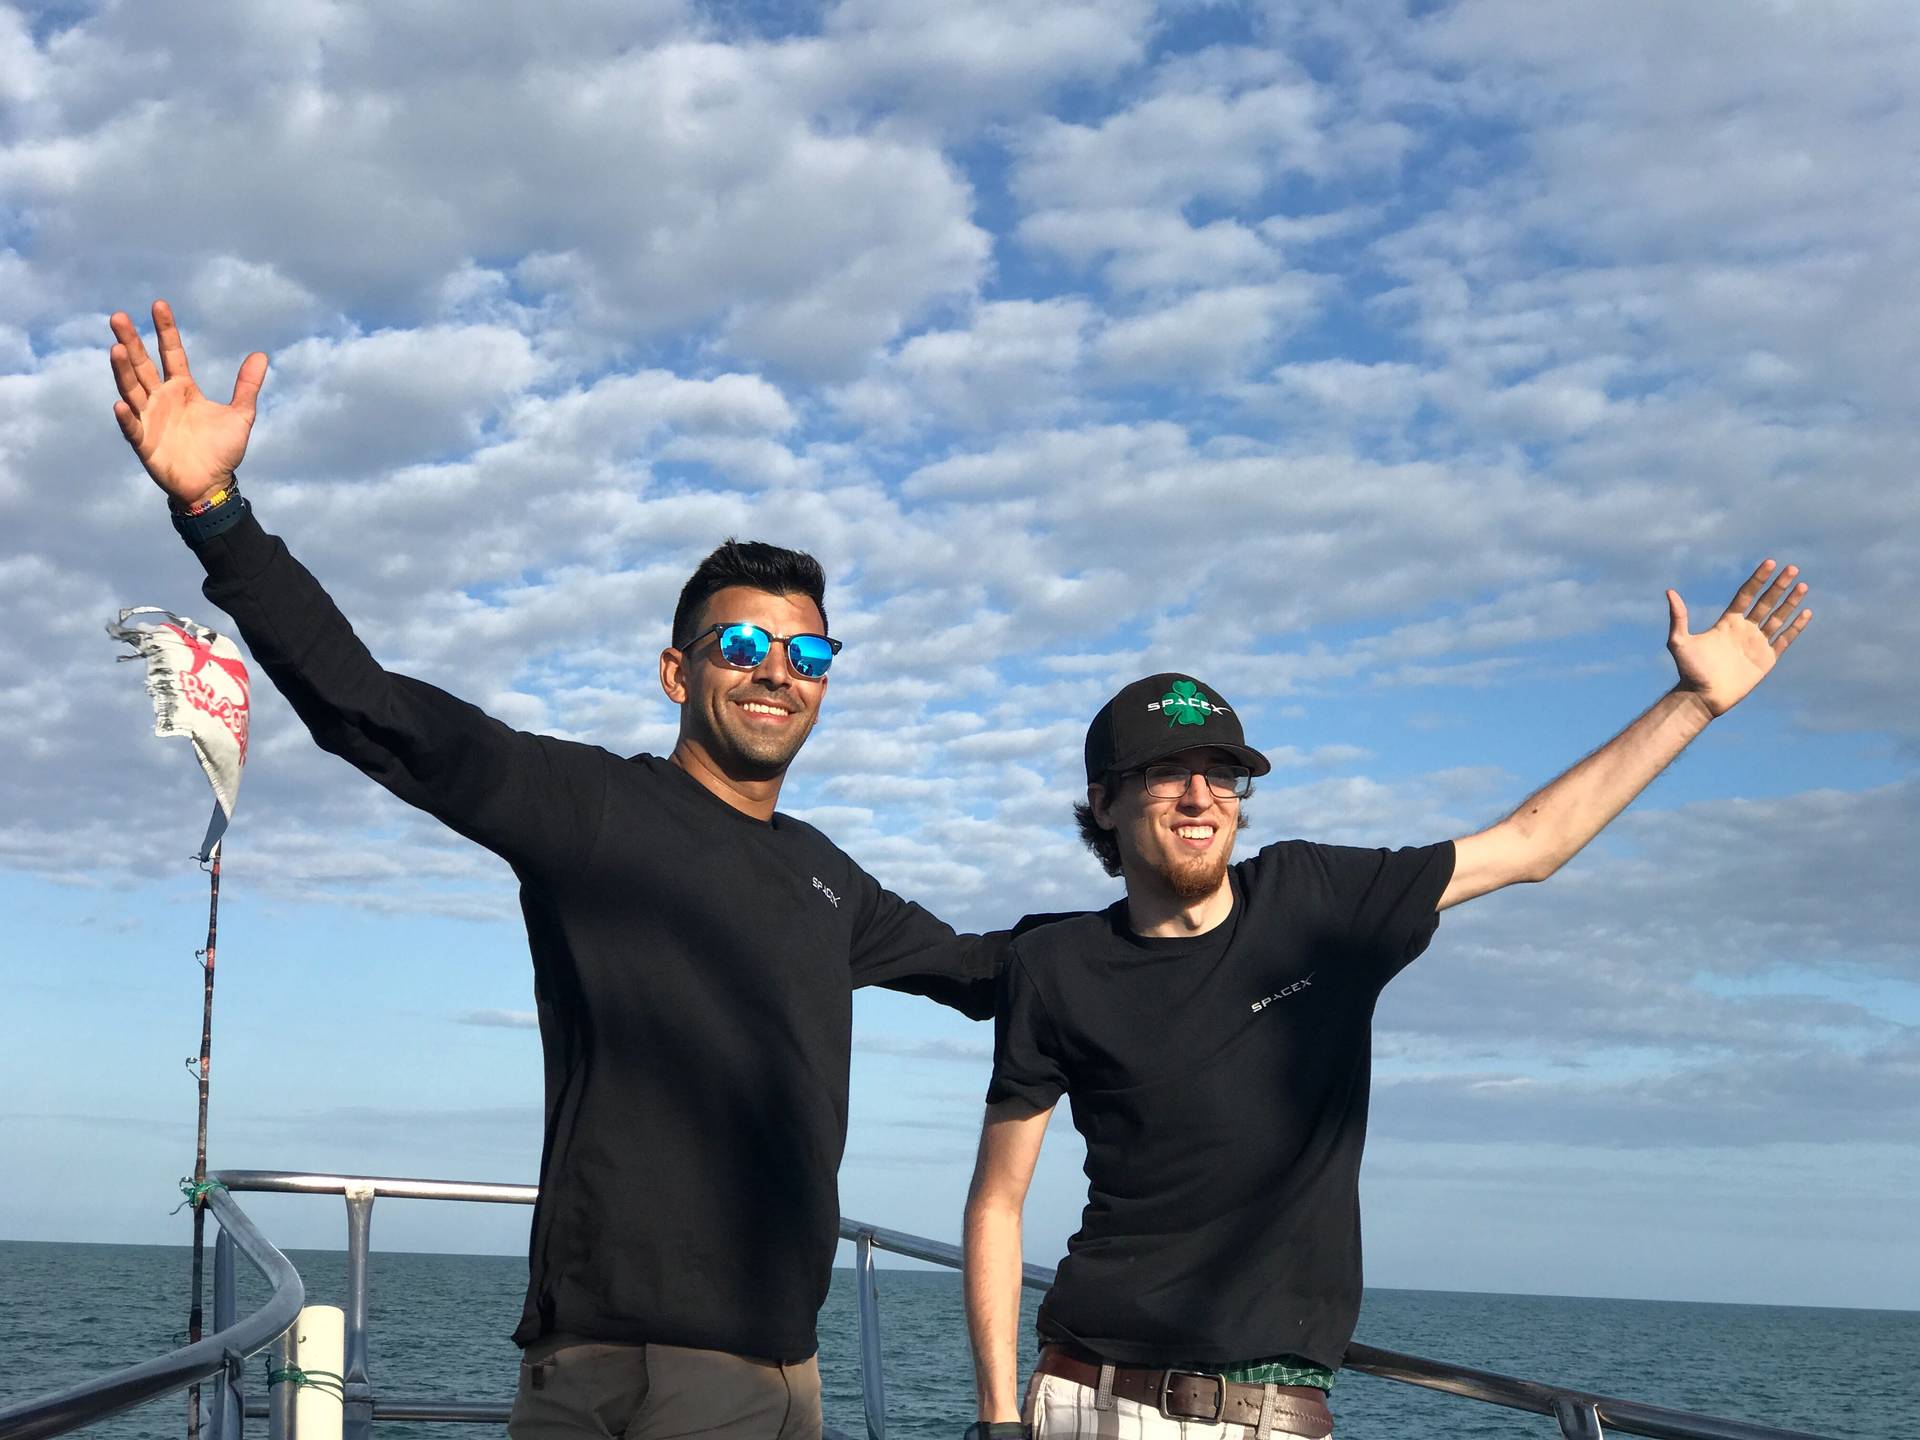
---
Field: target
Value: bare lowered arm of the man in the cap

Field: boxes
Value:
[964,1100,1054,1421]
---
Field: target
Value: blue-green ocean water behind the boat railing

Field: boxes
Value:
[0,1242,1920,1440]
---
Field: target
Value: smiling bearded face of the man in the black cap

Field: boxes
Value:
[1087,747,1240,902]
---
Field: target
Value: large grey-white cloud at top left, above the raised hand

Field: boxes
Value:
[15,6,987,372]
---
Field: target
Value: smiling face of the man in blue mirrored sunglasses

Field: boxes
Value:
[660,586,828,783]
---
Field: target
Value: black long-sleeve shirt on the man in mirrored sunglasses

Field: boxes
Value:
[198,516,1004,1361]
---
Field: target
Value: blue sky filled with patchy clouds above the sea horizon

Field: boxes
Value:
[0,0,1920,1308]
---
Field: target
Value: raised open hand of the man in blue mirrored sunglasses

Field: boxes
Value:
[108,300,267,505]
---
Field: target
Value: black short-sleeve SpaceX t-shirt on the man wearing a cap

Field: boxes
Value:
[987,841,1453,1369]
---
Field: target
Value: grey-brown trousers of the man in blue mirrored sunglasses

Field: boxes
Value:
[507,1338,820,1440]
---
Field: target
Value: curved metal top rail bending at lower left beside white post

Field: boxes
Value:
[0,1188,305,1440]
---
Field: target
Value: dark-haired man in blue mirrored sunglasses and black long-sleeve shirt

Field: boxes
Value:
[109,303,1004,1440]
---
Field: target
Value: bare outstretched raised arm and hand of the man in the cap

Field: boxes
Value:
[1440,561,1812,910]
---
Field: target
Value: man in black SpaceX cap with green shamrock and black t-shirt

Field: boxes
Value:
[966,561,1811,1440]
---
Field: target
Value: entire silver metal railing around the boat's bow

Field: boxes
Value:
[0,1169,1822,1440]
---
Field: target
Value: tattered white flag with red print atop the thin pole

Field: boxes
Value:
[108,605,252,860]
